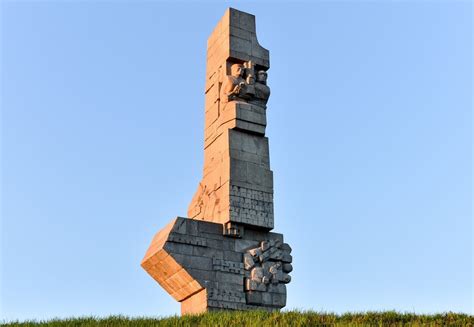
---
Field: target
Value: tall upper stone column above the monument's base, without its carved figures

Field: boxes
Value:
[188,8,274,232]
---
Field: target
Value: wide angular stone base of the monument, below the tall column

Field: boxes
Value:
[141,217,292,314]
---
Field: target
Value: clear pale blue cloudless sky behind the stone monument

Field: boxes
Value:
[0,1,473,320]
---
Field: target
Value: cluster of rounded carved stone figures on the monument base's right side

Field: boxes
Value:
[244,240,293,306]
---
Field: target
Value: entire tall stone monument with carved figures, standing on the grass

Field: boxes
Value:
[141,8,293,314]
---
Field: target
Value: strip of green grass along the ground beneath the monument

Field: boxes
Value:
[2,311,474,327]
